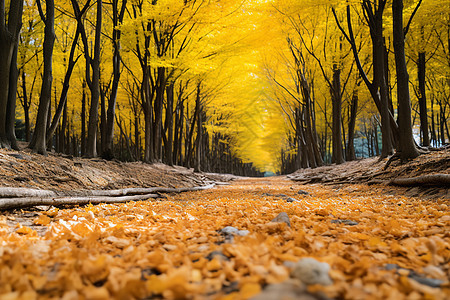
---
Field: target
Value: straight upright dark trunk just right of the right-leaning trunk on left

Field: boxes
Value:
[85,0,102,157]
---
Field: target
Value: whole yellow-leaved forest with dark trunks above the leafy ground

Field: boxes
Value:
[0,0,444,175]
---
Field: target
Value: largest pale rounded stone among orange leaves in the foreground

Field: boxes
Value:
[291,257,333,285]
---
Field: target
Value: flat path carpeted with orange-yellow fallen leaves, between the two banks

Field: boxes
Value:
[0,177,450,299]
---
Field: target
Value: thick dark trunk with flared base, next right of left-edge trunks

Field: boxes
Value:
[28,0,55,155]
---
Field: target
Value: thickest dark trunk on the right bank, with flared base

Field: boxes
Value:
[392,0,419,160]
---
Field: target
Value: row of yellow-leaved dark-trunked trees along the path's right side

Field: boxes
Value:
[265,0,450,172]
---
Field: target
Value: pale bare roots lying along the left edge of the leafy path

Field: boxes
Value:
[0,184,214,210]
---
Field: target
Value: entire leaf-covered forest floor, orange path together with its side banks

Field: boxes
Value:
[0,146,450,299]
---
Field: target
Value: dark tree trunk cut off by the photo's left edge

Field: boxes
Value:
[0,0,23,148]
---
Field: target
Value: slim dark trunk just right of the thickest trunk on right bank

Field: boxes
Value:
[417,52,430,147]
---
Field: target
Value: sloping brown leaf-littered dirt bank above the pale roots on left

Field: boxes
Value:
[0,149,230,194]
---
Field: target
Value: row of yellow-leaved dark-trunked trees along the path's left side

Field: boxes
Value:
[0,0,268,175]
